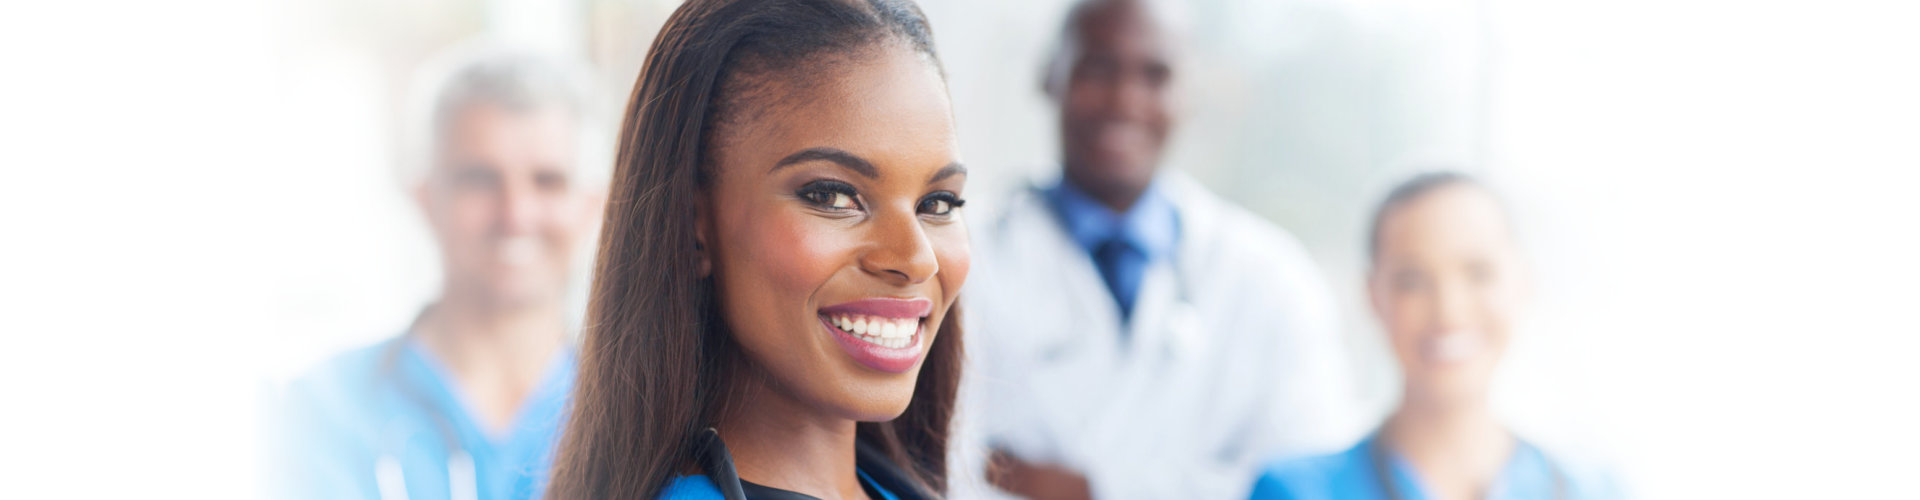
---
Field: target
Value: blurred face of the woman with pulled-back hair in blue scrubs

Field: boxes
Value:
[1367,185,1523,402]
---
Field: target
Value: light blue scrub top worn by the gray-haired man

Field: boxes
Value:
[267,337,576,500]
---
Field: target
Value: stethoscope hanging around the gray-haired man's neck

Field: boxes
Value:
[372,332,480,500]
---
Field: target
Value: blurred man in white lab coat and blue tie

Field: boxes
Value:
[954,0,1361,500]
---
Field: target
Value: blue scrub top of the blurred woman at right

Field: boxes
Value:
[1252,435,1620,500]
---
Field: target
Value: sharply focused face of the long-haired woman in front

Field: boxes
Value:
[701,48,970,421]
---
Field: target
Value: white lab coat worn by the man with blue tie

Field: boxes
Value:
[952,173,1361,500]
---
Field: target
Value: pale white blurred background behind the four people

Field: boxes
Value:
[0,0,1920,498]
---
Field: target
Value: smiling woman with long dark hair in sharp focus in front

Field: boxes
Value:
[549,0,970,498]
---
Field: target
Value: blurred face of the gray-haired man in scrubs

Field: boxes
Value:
[417,104,603,308]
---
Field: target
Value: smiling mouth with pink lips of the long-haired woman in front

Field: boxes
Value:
[818,298,933,373]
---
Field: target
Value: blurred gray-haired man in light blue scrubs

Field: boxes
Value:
[269,44,611,498]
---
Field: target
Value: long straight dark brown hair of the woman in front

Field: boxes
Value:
[547,0,962,500]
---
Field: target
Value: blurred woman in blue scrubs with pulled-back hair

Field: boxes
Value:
[1252,173,1619,500]
